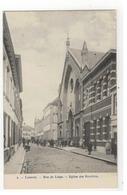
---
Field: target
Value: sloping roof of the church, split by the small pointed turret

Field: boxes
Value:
[69,48,104,69]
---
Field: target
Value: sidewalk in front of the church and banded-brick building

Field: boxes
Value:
[57,146,117,165]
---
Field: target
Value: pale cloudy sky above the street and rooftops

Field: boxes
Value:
[6,11,116,126]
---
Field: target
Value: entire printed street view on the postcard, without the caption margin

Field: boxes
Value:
[3,10,118,174]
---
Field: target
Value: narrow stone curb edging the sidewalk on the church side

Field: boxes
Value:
[55,147,117,165]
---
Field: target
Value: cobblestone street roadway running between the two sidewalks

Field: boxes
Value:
[22,144,117,173]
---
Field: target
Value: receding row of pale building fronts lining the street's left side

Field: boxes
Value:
[3,15,23,162]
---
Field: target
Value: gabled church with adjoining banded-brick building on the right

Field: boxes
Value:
[58,39,117,152]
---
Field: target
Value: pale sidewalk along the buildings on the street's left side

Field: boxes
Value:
[4,145,25,174]
